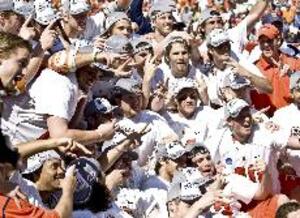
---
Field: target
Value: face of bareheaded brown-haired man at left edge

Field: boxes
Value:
[0,47,30,95]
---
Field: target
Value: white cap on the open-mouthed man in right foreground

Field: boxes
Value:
[225,98,249,119]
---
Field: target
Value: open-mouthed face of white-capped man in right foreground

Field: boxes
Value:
[228,107,253,142]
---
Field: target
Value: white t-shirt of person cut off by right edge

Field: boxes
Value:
[272,104,300,176]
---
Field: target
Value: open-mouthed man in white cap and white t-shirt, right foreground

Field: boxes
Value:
[207,99,292,216]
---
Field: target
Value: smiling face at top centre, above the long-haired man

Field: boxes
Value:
[154,12,174,36]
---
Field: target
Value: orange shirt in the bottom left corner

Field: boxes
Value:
[0,194,59,218]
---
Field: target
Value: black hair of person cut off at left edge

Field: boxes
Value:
[0,131,20,168]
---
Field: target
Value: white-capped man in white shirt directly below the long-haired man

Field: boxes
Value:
[164,78,219,146]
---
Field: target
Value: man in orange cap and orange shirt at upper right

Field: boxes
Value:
[253,24,300,116]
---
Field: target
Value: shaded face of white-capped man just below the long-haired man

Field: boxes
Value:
[176,88,199,119]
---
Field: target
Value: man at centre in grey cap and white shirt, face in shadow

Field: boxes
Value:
[112,78,174,166]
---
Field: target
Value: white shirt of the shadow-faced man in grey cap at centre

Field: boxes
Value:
[112,110,174,166]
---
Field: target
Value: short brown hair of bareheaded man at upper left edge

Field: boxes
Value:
[0,32,32,58]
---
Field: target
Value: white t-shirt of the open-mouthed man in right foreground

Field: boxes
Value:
[206,124,289,197]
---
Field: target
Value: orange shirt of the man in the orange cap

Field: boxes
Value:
[251,54,300,115]
